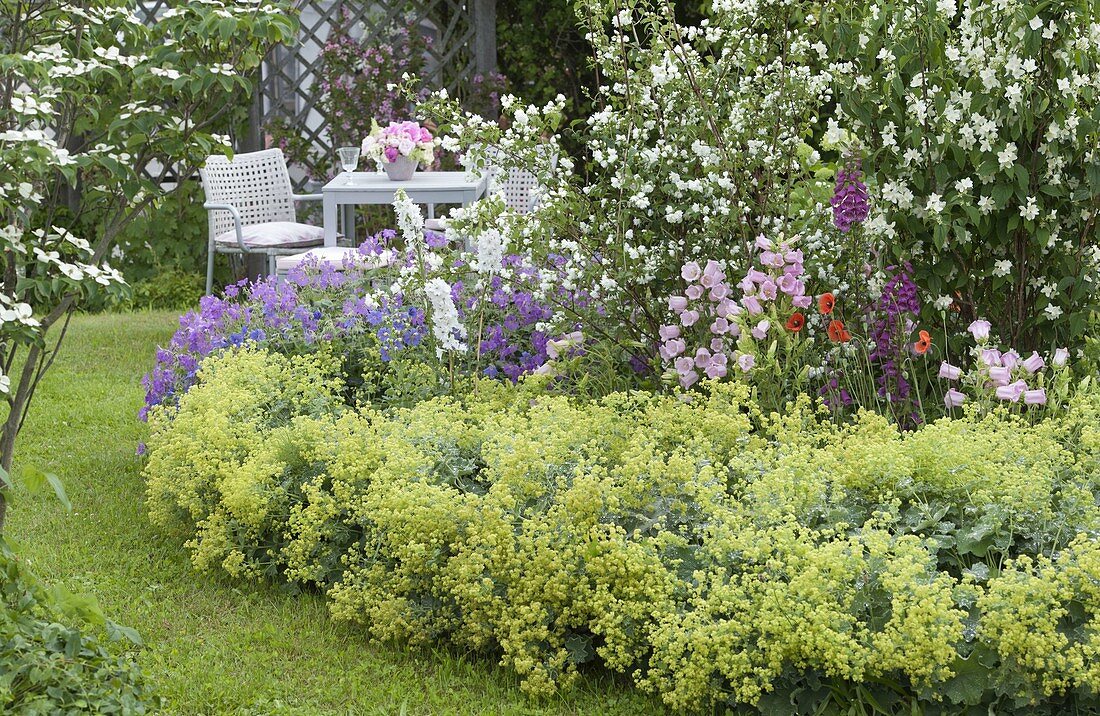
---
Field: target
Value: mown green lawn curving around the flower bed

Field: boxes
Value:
[8,313,663,716]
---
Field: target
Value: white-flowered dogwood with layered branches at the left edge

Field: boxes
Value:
[0,0,296,526]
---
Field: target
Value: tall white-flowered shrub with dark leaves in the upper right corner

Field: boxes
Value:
[825,0,1100,349]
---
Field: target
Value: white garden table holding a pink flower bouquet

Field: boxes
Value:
[321,172,488,246]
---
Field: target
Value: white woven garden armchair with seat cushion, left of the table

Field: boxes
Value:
[199,148,325,294]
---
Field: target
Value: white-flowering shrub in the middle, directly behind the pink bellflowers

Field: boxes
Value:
[420,0,833,365]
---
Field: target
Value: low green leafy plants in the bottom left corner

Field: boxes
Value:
[0,539,154,715]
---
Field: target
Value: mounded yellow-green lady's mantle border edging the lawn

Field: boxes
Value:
[145,345,1100,714]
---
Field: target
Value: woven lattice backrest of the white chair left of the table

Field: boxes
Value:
[199,148,296,239]
